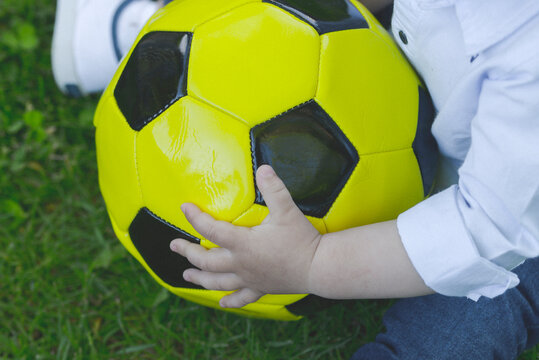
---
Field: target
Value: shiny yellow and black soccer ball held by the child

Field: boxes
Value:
[94,0,436,320]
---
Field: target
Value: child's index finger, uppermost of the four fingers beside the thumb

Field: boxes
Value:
[182,203,248,249]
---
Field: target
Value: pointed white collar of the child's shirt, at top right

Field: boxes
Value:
[417,0,539,55]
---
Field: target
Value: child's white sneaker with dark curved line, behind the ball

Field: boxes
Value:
[51,0,159,97]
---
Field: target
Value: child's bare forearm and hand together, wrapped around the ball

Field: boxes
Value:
[171,166,432,307]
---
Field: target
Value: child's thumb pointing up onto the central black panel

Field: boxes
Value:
[256,165,302,220]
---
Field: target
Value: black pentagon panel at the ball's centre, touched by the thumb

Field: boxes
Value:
[251,100,359,218]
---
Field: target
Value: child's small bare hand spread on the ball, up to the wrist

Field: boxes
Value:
[170,165,322,307]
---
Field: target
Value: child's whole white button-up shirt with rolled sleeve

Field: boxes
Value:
[392,0,539,300]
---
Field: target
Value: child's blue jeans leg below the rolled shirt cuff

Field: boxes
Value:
[352,258,539,360]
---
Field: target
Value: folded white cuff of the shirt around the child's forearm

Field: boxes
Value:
[397,185,519,301]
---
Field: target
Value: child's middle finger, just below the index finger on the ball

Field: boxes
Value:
[170,239,233,272]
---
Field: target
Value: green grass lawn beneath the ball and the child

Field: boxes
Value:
[0,0,539,360]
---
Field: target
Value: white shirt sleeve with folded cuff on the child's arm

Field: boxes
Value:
[397,54,539,300]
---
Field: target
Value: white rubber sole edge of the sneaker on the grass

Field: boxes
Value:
[51,0,84,97]
